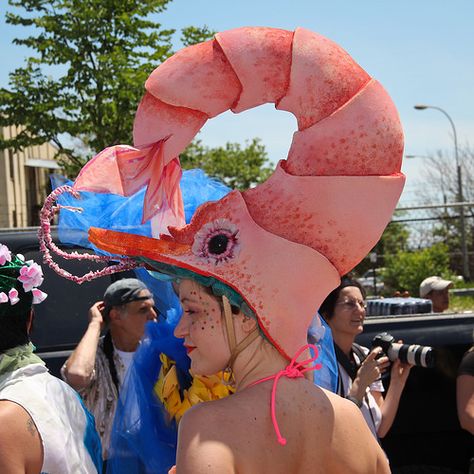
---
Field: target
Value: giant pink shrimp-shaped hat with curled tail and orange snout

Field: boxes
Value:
[50,27,404,359]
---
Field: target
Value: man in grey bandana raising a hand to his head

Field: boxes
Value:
[61,278,156,459]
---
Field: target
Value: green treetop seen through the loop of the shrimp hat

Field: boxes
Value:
[180,138,274,190]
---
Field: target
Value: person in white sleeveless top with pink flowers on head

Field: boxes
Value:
[0,244,102,474]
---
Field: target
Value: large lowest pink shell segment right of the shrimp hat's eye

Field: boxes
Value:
[243,162,405,275]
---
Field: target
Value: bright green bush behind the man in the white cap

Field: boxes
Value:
[384,243,452,296]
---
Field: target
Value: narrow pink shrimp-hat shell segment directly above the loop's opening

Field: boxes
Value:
[216,27,293,113]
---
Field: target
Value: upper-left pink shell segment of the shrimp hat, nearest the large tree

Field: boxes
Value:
[145,40,241,117]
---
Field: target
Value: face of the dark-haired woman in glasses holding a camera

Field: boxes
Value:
[328,286,365,337]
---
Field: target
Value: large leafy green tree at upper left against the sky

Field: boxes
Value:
[0,0,212,176]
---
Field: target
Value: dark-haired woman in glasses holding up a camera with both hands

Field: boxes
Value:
[319,276,412,438]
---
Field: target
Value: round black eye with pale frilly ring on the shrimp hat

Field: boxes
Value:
[192,219,240,265]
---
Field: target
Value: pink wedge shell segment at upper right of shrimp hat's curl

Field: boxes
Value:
[277,28,370,130]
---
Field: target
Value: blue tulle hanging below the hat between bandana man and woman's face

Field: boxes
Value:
[107,282,191,474]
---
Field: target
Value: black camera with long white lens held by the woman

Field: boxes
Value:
[372,332,435,368]
